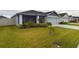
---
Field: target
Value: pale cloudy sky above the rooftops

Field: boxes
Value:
[0,10,79,18]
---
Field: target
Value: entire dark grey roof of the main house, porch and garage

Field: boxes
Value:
[11,10,58,18]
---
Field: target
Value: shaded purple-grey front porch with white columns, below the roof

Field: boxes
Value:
[16,15,45,24]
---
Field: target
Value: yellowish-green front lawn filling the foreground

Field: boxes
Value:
[0,26,79,48]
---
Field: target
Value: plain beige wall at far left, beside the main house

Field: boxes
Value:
[0,18,16,26]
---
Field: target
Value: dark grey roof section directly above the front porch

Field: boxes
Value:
[17,10,45,16]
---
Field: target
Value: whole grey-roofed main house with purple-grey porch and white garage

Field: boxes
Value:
[12,10,59,25]
